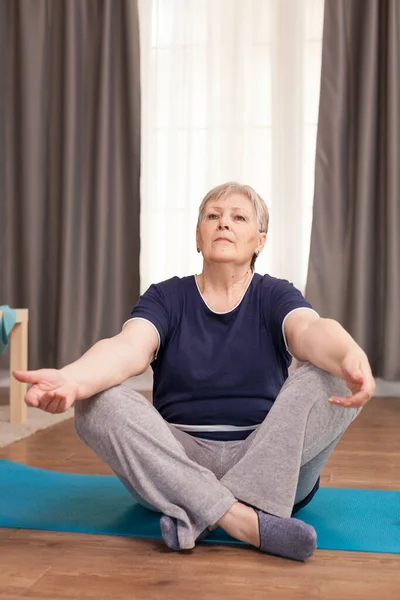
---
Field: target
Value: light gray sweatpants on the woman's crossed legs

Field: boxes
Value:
[75,363,361,549]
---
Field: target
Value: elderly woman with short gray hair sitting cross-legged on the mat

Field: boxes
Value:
[15,183,374,560]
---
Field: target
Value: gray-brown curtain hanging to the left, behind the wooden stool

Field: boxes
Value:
[0,0,140,368]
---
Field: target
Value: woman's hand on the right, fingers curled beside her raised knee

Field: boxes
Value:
[329,352,375,408]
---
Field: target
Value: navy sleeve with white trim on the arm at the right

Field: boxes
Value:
[269,279,315,354]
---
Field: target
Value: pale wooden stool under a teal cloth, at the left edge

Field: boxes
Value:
[0,308,29,423]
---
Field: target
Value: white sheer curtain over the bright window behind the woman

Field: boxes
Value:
[139,0,324,291]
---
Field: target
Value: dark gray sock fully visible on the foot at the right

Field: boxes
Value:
[255,509,317,560]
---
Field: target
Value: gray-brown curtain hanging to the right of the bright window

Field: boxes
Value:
[306,0,400,380]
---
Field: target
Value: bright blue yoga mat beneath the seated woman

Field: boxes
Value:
[0,460,400,554]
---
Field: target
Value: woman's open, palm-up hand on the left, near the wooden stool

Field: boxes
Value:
[13,369,78,413]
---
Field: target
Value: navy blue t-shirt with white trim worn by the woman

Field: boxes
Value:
[125,273,311,440]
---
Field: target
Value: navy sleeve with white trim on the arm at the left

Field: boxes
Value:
[123,284,170,346]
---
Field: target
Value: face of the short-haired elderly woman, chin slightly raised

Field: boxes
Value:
[196,194,267,265]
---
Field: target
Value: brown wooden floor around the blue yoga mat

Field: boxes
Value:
[0,398,400,600]
